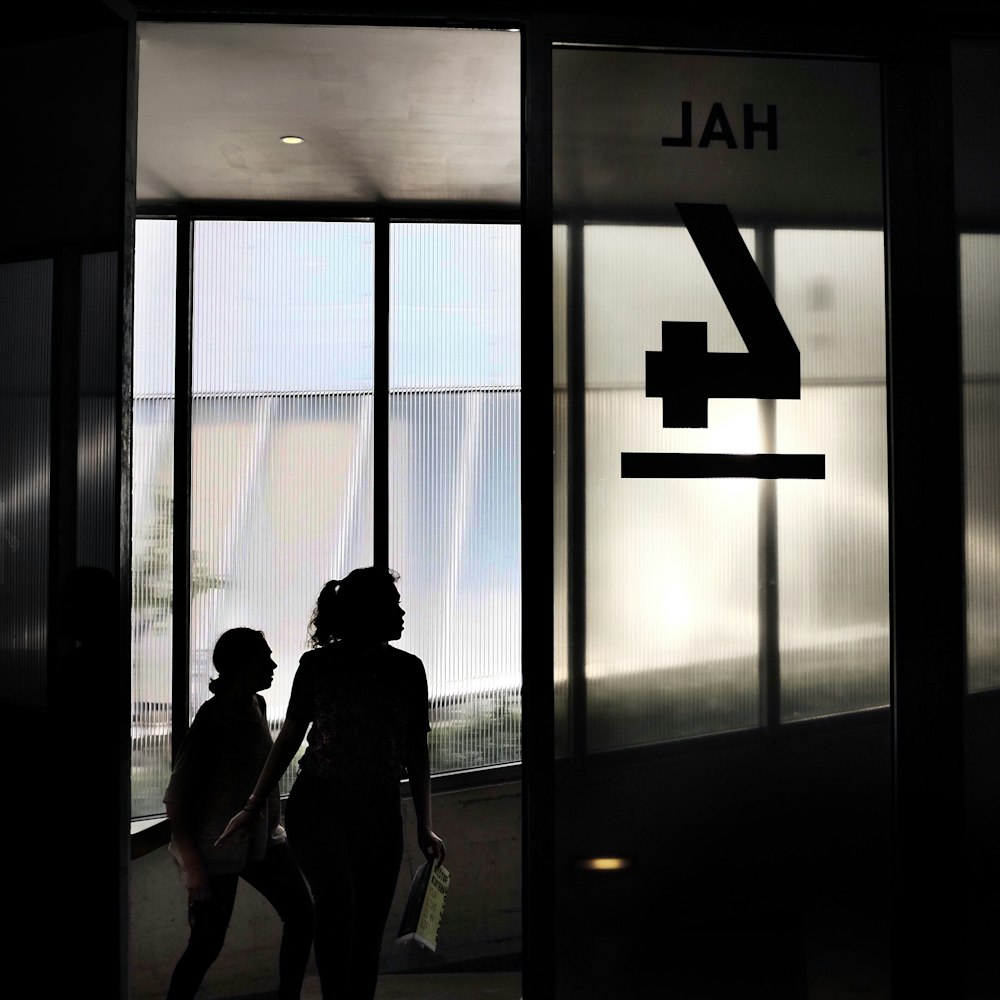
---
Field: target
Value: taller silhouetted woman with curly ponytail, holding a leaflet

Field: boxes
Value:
[221,567,445,1000]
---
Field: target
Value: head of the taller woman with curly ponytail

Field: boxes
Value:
[309,566,406,646]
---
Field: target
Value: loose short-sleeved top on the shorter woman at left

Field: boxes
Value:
[163,695,283,875]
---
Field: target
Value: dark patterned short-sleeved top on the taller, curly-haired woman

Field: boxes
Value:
[288,641,430,794]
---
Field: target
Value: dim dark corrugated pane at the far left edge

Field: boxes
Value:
[0,260,53,707]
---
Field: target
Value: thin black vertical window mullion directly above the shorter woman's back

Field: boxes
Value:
[170,212,194,759]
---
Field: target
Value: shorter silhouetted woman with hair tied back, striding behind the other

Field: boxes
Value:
[163,628,313,1000]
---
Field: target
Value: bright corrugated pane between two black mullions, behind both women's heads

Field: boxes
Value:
[190,222,373,791]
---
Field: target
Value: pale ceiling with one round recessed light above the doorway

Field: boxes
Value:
[136,22,521,206]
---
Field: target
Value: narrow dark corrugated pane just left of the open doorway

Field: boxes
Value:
[76,251,120,575]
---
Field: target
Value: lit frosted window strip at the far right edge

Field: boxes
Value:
[959,233,1000,691]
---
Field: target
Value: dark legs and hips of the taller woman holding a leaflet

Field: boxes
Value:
[286,777,403,1000]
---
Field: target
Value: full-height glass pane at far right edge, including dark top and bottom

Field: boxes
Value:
[952,37,1000,998]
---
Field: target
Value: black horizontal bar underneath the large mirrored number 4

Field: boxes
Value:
[622,451,826,479]
